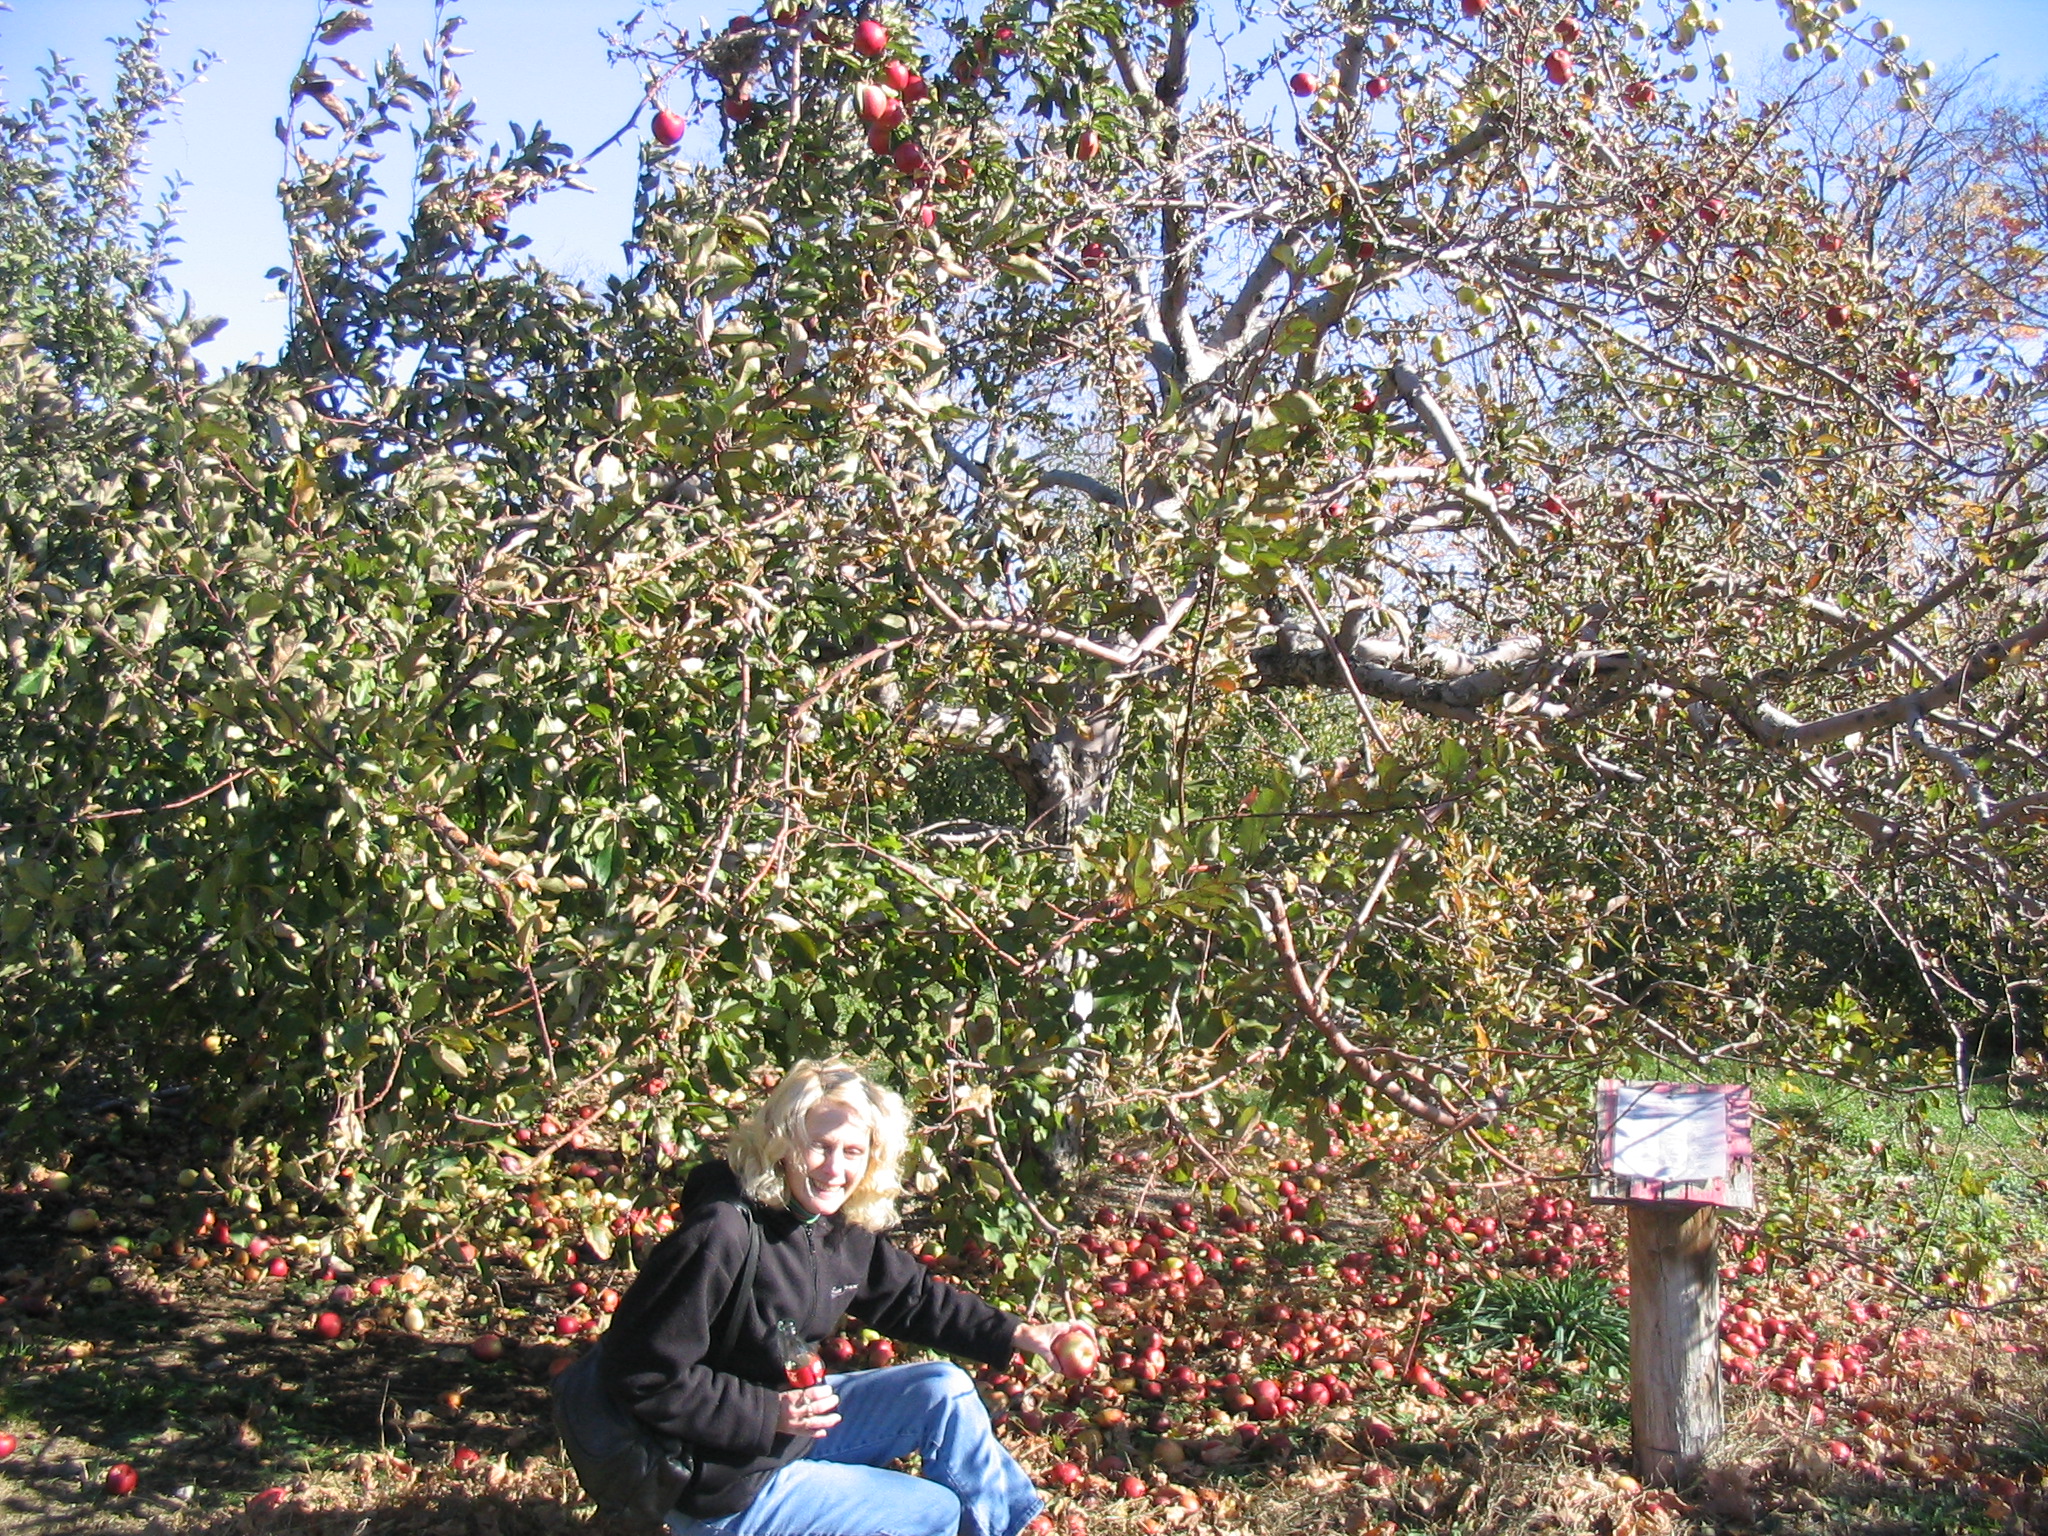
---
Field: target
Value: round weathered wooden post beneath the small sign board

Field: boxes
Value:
[1628,1202,1722,1487]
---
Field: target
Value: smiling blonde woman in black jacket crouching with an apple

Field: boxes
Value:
[604,1061,1085,1536]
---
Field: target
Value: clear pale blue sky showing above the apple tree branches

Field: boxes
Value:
[0,0,2048,362]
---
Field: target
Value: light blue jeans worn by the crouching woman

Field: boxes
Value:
[668,1360,1040,1536]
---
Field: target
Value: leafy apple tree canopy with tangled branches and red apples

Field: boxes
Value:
[0,0,2048,1243]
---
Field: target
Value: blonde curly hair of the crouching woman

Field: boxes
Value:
[725,1057,909,1233]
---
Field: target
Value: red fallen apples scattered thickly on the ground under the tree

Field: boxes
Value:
[12,1126,2019,1524]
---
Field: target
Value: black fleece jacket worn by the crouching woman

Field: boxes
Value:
[602,1163,1018,1520]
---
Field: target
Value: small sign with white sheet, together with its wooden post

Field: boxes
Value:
[1593,1077,1755,1485]
